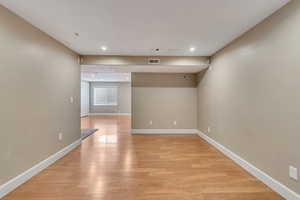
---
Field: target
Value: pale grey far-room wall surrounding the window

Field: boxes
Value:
[90,82,131,114]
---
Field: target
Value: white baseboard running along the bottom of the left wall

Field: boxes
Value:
[0,139,81,199]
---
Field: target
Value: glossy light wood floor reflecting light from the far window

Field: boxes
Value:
[3,116,283,200]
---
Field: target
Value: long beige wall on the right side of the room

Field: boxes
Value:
[198,0,300,193]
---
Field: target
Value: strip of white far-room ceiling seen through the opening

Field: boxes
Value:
[81,72,131,82]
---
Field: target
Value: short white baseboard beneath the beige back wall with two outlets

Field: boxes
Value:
[131,129,199,134]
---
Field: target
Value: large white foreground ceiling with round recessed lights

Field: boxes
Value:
[0,0,289,56]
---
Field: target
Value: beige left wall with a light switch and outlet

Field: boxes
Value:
[0,6,80,184]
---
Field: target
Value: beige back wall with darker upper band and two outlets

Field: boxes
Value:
[132,73,197,129]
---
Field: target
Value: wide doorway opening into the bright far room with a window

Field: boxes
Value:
[81,70,132,142]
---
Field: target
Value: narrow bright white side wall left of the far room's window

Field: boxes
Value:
[80,81,90,117]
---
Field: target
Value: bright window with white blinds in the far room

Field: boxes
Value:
[94,87,118,106]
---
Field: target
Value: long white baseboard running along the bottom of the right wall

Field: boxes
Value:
[198,131,300,200]
